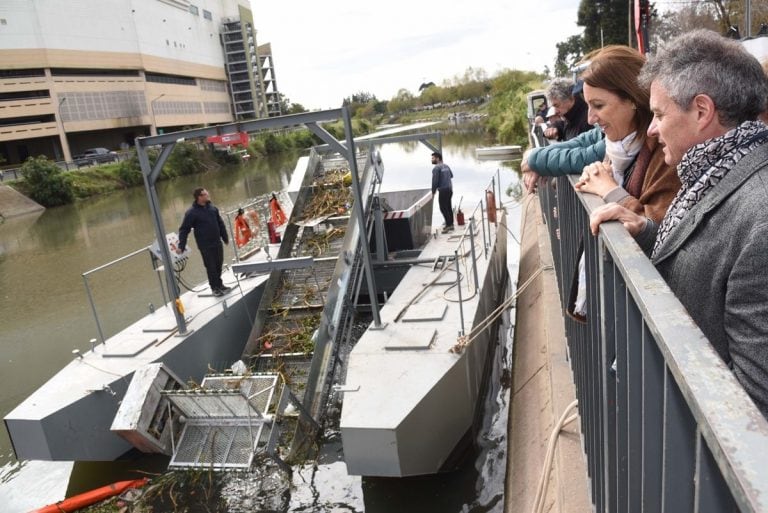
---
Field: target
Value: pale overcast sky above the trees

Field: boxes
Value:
[251,0,581,110]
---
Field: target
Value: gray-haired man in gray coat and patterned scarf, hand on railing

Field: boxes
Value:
[590,30,768,417]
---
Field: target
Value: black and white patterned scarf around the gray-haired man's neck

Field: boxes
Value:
[651,121,768,258]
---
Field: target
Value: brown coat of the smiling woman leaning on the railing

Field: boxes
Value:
[616,137,680,223]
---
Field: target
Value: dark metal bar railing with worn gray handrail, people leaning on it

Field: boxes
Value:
[539,177,768,513]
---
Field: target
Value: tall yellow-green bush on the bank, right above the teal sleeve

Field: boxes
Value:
[487,70,544,145]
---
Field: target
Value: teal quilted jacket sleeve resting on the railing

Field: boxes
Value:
[528,127,605,176]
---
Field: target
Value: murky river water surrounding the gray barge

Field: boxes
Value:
[0,125,519,512]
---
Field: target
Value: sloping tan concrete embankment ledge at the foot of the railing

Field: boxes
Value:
[505,196,592,513]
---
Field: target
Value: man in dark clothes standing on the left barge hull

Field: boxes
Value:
[178,187,231,297]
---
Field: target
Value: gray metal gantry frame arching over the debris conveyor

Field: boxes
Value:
[136,107,381,336]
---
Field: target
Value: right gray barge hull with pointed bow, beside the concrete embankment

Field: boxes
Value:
[341,208,508,477]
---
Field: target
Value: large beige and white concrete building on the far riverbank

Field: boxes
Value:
[0,0,280,164]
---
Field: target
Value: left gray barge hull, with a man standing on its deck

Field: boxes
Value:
[5,273,266,461]
